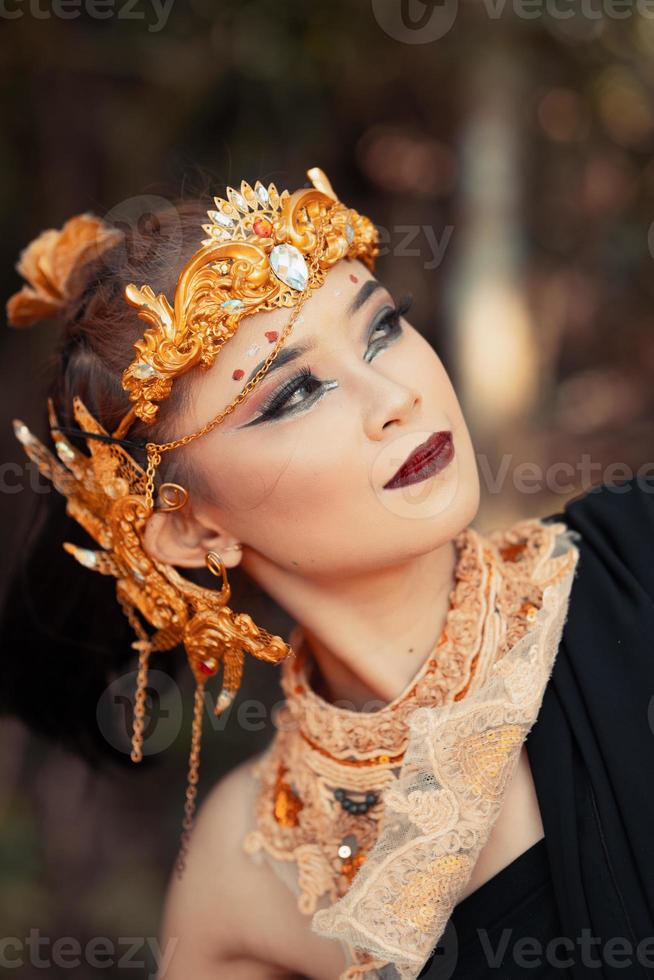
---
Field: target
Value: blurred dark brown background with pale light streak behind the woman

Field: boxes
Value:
[0,0,654,978]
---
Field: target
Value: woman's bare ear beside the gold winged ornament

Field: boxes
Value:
[144,502,242,568]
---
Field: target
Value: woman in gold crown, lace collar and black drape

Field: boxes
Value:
[8,168,654,980]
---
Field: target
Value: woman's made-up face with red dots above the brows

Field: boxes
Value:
[174,260,479,579]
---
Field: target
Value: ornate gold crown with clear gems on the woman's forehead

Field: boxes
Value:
[120,167,379,434]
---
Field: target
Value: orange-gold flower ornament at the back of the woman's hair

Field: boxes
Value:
[7,213,123,327]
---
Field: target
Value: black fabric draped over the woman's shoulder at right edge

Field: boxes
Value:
[526,477,654,980]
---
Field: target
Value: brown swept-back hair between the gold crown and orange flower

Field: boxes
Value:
[52,198,218,492]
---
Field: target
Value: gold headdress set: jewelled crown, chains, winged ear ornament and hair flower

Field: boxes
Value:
[7,167,379,875]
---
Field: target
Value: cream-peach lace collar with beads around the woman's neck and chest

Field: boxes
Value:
[243,519,579,980]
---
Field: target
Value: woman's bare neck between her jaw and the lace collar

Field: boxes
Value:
[243,540,457,710]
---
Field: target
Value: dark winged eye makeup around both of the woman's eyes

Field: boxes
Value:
[240,293,413,428]
